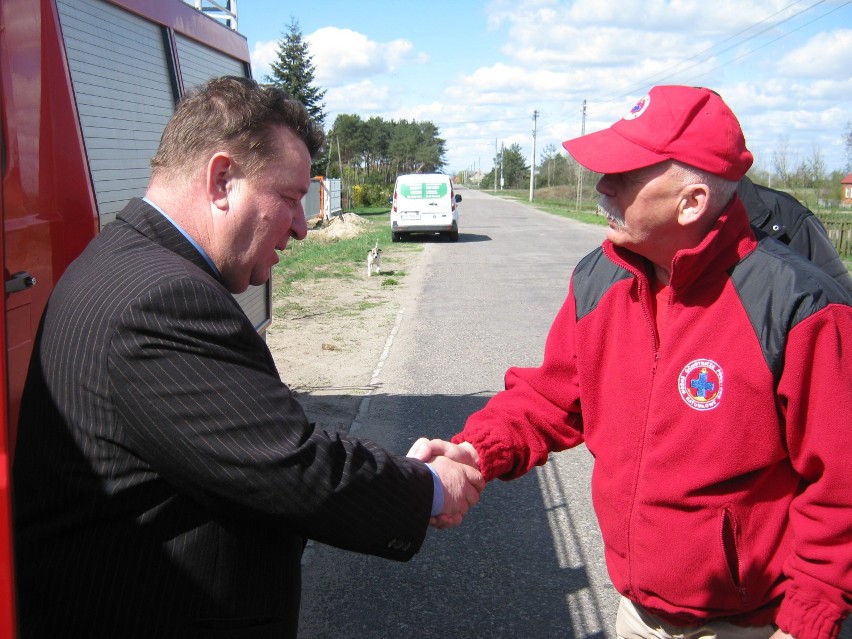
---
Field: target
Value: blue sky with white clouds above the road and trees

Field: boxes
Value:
[233,0,852,173]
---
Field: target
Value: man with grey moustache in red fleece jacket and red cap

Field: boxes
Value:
[413,86,852,639]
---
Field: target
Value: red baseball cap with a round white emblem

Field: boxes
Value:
[562,86,754,181]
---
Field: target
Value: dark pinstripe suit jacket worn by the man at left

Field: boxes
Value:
[14,200,433,638]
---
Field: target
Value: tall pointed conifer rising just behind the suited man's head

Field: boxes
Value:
[266,17,326,126]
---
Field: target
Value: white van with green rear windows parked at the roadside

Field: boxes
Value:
[391,173,461,242]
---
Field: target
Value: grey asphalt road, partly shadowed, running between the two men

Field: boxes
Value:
[300,190,618,639]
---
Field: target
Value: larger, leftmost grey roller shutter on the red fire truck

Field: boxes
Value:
[56,0,175,228]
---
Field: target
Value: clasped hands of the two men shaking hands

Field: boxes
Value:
[407,437,485,529]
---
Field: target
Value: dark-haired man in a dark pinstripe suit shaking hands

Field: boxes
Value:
[14,77,483,638]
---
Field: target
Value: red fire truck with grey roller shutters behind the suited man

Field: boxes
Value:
[0,0,260,639]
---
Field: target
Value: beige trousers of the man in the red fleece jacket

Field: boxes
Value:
[615,597,775,639]
